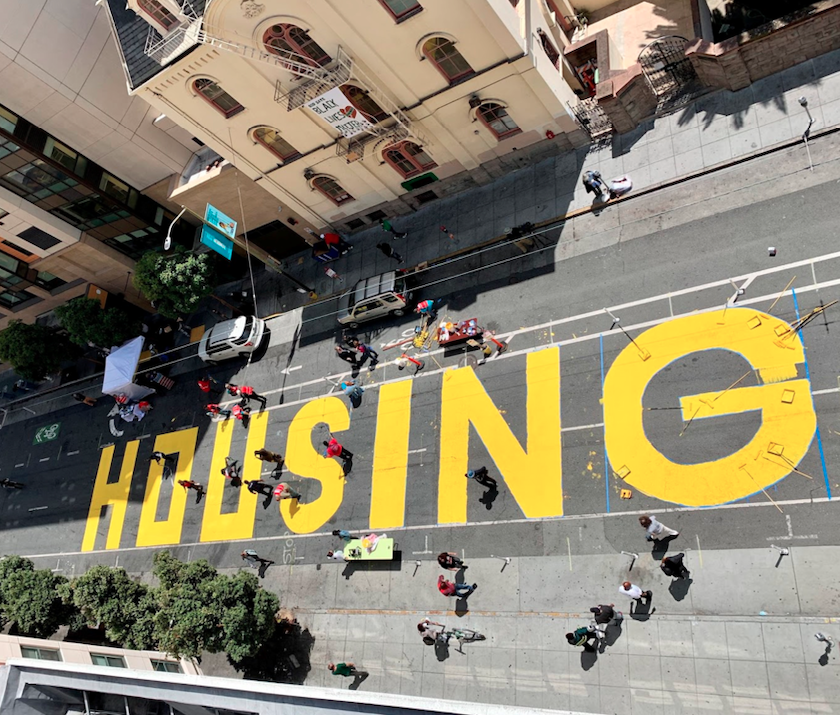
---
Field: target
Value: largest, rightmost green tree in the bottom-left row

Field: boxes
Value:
[154,552,279,662]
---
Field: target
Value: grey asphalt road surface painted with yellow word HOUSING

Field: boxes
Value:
[0,183,840,570]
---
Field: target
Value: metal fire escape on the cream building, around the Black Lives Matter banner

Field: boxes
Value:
[145,10,426,163]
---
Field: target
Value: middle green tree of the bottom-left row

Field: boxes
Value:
[61,566,157,650]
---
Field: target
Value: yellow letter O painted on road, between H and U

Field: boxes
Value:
[137,427,198,546]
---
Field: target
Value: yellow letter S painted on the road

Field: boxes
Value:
[280,397,353,534]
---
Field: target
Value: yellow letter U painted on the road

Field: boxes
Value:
[199,412,268,542]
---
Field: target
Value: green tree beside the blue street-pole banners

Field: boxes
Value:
[134,246,214,318]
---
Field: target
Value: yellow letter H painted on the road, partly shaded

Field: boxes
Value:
[82,439,140,551]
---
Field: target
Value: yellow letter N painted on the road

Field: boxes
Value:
[438,347,563,524]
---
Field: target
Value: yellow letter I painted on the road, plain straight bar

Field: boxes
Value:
[370,380,413,529]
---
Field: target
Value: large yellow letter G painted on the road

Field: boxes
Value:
[604,308,817,506]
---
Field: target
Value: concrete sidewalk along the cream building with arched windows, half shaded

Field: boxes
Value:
[257,44,840,315]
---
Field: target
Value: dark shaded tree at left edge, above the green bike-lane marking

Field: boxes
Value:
[0,319,68,381]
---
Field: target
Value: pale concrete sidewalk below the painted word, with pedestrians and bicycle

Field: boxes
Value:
[256,544,840,715]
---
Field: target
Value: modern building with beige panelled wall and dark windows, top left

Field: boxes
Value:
[0,0,201,329]
